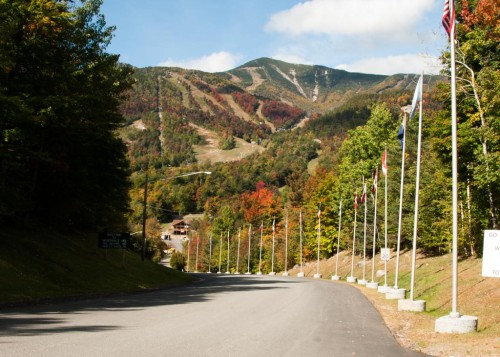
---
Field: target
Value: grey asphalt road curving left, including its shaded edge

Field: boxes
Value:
[0,274,423,357]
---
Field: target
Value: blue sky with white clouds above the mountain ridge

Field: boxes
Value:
[101,0,447,75]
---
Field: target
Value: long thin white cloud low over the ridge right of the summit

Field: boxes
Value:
[335,54,442,75]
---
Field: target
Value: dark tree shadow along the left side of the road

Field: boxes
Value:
[0,274,297,336]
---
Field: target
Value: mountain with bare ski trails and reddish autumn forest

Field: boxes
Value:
[122,58,439,169]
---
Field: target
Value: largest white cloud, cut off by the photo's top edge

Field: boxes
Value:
[266,0,435,36]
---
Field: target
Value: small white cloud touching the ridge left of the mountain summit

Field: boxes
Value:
[158,51,241,72]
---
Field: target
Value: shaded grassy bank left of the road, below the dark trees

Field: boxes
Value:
[0,230,192,303]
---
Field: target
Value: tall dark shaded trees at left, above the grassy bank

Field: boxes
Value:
[0,0,131,228]
